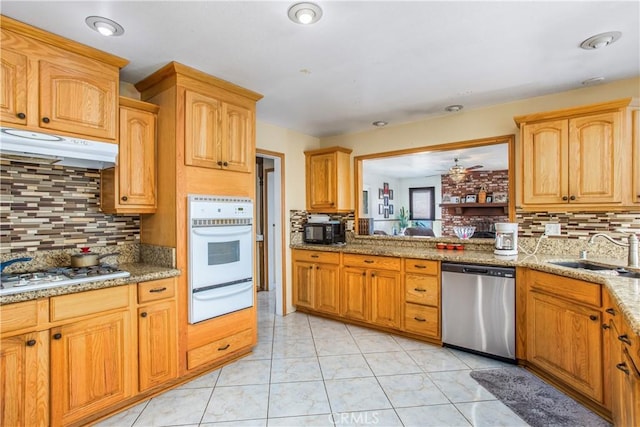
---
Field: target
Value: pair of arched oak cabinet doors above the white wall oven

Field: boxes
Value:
[185,90,254,172]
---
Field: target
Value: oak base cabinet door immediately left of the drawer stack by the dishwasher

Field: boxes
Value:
[370,270,402,328]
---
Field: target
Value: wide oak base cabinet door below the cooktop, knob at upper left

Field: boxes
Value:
[51,312,136,425]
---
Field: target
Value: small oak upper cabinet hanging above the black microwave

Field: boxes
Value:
[304,147,353,213]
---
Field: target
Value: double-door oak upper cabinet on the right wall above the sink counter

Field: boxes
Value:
[515,99,632,210]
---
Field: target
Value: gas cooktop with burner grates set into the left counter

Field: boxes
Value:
[0,265,130,296]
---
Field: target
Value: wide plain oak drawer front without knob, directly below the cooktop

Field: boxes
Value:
[50,286,129,322]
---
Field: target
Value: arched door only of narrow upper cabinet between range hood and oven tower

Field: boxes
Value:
[118,107,156,207]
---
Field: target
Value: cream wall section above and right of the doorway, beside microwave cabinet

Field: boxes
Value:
[256,121,320,313]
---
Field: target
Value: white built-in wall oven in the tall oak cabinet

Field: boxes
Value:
[188,194,255,324]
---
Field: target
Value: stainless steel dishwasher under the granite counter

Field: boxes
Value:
[442,263,516,362]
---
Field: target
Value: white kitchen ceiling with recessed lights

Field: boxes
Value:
[2,0,640,137]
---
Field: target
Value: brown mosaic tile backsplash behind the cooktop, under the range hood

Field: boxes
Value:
[0,160,140,254]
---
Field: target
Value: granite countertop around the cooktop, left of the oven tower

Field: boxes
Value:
[0,263,181,305]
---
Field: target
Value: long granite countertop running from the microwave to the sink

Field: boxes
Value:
[290,243,640,335]
